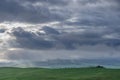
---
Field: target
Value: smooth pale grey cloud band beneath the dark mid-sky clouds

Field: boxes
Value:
[4,45,120,61]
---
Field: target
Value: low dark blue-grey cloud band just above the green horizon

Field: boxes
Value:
[30,58,120,68]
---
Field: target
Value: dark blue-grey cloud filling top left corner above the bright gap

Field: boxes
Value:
[0,0,68,23]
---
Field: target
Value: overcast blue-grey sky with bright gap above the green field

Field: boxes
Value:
[0,0,120,67]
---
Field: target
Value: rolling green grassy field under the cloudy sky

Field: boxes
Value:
[0,68,120,80]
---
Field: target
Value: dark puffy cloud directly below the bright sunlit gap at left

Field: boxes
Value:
[12,27,53,49]
